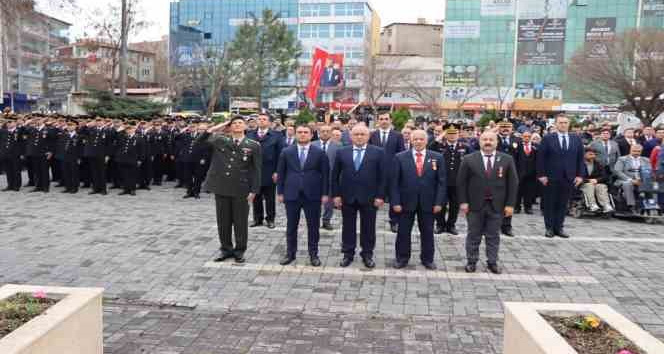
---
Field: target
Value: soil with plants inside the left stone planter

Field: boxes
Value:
[0,293,58,339]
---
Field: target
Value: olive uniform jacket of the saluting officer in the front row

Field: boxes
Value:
[203,134,262,197]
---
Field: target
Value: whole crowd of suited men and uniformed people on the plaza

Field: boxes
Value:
[0,113,664,273]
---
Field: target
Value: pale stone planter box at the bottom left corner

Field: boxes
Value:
[0,285,104,354]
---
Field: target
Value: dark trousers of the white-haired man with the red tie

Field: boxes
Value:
[395,207,436,264]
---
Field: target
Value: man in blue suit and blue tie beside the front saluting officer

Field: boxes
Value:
[277,125,330,267]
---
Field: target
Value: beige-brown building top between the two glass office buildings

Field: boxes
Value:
[380,19,443,58]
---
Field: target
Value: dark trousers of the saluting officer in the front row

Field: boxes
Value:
[215,195,249,256]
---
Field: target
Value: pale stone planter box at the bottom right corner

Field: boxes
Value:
[503,302,664,354]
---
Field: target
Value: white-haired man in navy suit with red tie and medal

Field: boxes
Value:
[390,130,447,270]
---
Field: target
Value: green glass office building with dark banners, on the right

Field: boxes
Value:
[443,0,664,111]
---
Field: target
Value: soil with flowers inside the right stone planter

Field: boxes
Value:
[542,315,646,354]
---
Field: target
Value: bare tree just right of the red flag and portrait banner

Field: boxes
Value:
[360,55,411,113]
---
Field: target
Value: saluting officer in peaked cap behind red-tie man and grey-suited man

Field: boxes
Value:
[429,125,472,235]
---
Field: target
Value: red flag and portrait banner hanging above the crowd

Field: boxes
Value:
[306,48,345,103]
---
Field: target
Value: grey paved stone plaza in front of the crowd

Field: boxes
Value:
[0,178,664,354]
